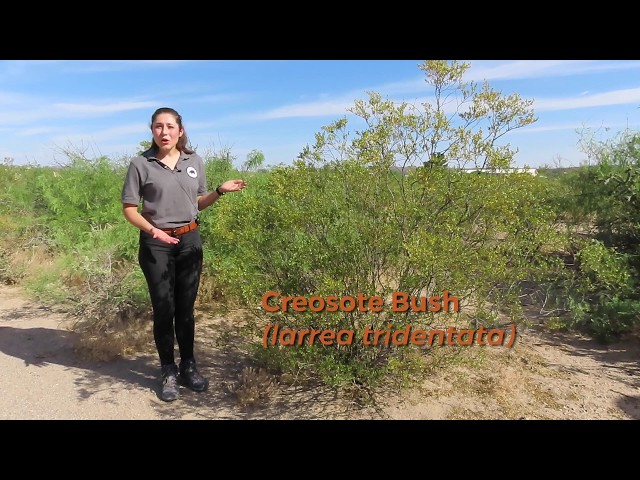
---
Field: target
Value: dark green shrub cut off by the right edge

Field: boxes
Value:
[554,131,640,342]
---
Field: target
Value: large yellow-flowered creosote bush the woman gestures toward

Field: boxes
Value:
[201,62,564,396]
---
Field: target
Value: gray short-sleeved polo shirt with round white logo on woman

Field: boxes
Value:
[122,149,207,228]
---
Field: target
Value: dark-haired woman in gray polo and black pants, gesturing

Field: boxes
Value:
[122,107,247,402]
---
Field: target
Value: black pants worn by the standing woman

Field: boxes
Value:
[138,230,202,365]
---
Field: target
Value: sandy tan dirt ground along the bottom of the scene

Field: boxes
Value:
[0,285,640,420]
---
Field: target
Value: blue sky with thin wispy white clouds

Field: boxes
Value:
[0,60,640,167]
